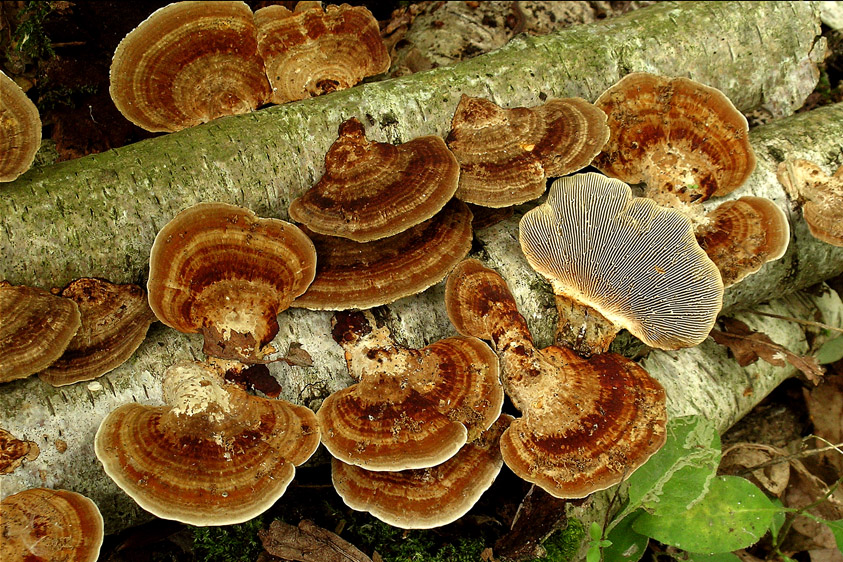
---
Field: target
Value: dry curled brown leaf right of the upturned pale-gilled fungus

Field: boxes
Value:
[711,318,824,384]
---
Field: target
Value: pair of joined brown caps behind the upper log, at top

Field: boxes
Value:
[110,1,389,132]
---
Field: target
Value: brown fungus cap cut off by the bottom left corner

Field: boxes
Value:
[0,488,103,562]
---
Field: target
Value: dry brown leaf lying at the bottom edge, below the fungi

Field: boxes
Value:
[258,519,372,562]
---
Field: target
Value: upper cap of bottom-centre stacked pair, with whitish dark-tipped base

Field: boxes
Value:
[317,312,503,471]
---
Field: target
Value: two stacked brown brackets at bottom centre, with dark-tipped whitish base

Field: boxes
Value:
[317,312,507,528]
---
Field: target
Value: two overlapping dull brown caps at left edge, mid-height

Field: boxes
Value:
[0,278,155,386]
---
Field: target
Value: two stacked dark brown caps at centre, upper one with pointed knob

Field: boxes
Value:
[290,119,472,310]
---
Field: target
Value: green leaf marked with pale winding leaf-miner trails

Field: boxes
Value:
[609,416,720,529]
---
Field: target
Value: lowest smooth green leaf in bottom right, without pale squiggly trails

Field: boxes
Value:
[632,476,779,554]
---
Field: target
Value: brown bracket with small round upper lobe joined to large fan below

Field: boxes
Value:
[445,260,667,498]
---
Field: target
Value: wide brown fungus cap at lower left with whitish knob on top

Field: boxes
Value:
[94,362,319,525]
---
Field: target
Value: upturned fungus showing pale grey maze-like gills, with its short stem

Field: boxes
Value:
[520,172,723,355]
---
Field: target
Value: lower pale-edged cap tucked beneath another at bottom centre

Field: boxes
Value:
[331,414,512,529]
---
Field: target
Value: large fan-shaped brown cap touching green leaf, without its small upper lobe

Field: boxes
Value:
[501,344,667,498]
